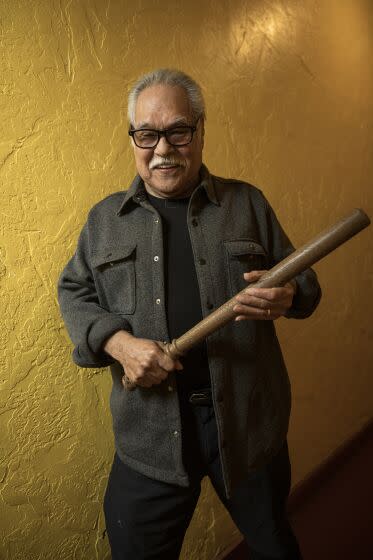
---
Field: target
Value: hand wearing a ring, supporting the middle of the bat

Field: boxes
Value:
[233,270,296,321]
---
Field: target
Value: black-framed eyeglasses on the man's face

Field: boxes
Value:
[128,119,199,150]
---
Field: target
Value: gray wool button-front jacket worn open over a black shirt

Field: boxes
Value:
[58,166,321,496]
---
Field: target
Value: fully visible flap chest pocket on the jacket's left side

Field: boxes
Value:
[92,245,136,315]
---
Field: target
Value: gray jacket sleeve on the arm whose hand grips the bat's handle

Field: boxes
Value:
[58,224,131,367]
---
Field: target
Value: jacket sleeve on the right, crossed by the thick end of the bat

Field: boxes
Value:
[258,192,321,319]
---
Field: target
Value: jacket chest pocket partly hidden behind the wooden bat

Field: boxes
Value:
[224,239,267,296]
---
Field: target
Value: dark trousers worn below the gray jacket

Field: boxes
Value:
[104,402,301,560]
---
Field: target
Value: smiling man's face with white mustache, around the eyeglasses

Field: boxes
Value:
[133,85,204,198]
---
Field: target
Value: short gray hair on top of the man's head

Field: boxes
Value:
[127,68,206,124]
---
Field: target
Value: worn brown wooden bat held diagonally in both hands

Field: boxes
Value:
[124,208,370,390]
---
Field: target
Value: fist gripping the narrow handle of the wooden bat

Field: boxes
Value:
[104,331,183,387]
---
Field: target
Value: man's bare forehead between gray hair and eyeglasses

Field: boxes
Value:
[135,84,191,128]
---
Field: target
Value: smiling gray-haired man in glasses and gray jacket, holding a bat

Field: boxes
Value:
[59,69,320,560]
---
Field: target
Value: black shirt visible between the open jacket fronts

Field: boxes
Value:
[147,193,210,392]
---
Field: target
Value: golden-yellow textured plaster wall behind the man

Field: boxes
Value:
[0,0,373,560]
